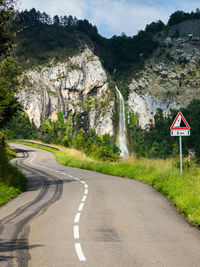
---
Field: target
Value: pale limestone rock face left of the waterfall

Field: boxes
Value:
[18,47,114,135]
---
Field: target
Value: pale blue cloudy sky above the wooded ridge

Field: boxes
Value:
[18,0,200,38]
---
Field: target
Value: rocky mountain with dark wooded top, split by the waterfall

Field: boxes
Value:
[10,9,200,156]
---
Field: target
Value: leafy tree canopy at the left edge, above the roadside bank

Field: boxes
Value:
[0,0,21,128]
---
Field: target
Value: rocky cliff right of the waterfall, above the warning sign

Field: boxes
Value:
[127,36,200,128]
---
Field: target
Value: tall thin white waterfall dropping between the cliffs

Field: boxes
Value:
[115,86,129,158]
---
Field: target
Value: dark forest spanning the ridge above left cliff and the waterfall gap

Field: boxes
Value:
[13,8,159,77]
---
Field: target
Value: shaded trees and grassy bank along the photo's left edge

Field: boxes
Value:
[0,0,26,206]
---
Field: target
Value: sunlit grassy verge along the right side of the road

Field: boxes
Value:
[13,143,200,226]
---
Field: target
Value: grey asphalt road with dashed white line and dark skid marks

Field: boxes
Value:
[0,144,200,267]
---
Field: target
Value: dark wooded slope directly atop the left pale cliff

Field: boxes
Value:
[13,8,99,68]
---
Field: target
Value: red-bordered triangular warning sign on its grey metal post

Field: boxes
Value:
[170,112,190,175]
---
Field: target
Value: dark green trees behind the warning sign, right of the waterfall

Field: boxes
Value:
[128,100,200,160]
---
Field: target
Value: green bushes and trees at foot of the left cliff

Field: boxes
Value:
[4,112,119,161]
